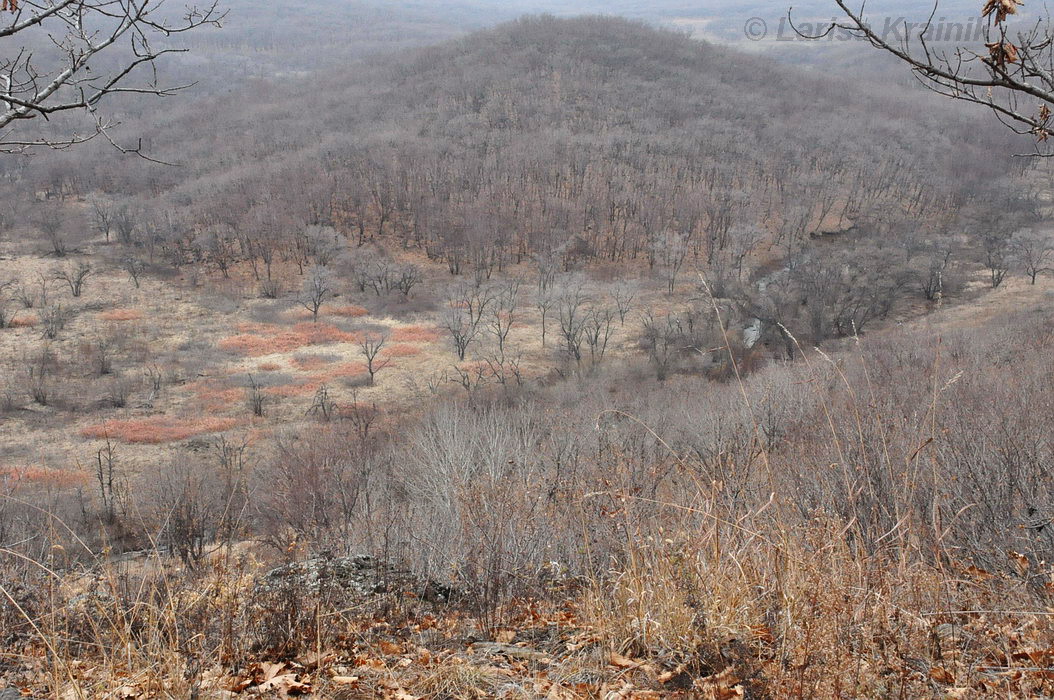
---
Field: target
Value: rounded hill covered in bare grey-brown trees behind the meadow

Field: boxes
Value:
[8,16,1020,265]
